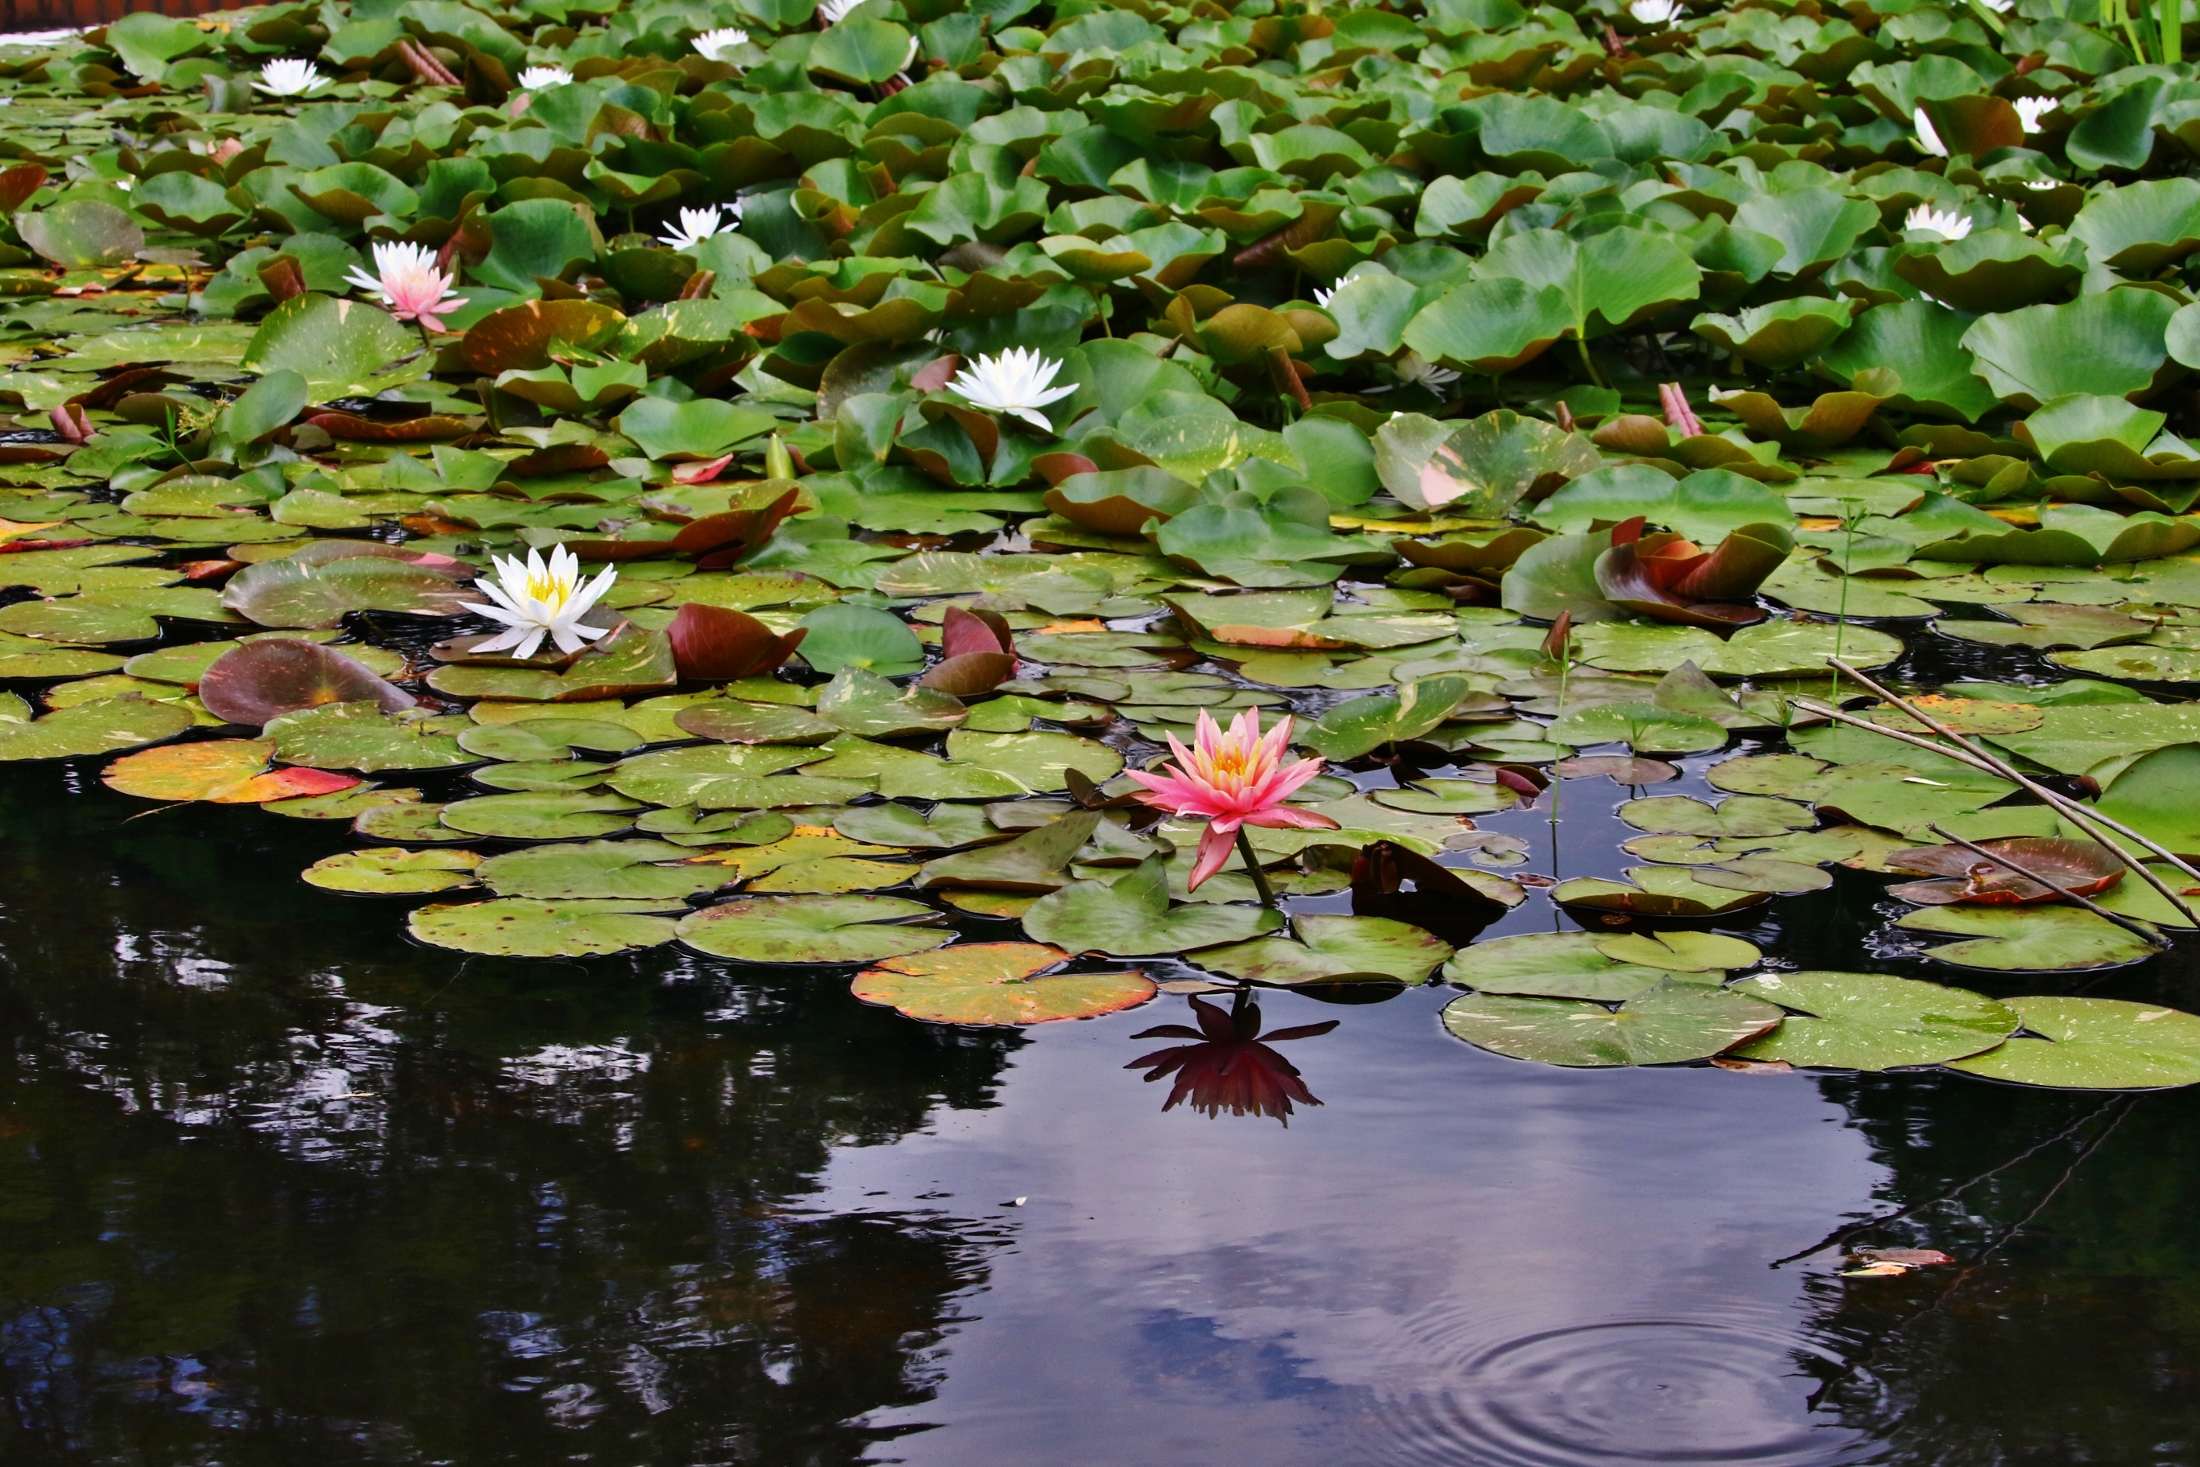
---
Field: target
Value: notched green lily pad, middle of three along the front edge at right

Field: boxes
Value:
[1734,970,2017,1069]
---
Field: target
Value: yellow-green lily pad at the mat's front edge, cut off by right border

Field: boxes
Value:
[1949,996,2200,1091]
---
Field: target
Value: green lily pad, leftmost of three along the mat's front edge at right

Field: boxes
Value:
[1443,979,1780,1067]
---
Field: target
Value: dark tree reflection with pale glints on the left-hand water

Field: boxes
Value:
[0,770,1021,1467]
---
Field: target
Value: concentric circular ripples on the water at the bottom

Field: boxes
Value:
[1379,1320,1872,1467]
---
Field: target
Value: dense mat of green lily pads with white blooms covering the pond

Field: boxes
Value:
[0,0,2200,1087]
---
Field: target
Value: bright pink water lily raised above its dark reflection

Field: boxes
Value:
[1126,708,1338,891]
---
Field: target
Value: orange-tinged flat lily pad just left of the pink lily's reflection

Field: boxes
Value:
[851,941,1157,1025]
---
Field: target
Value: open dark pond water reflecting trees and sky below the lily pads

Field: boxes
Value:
[0,717,2200,1467]
